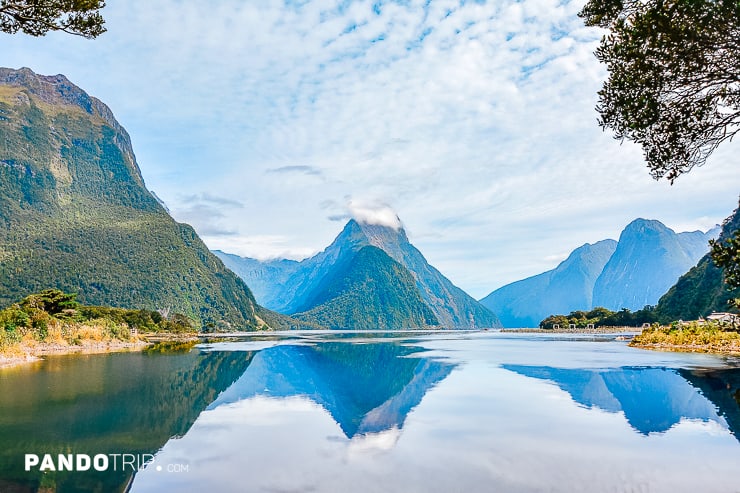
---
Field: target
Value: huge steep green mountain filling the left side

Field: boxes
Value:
[0,68,262,329]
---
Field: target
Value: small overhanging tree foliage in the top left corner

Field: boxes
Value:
[0,0,105,38]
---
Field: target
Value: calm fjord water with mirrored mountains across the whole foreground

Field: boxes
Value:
[0,332,740,492]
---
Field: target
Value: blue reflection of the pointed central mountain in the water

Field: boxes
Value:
[209,342,455,438]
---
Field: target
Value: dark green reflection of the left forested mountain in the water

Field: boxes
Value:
[0,350,252,493]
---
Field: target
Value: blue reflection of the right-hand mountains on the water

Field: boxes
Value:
[503,365,725,435]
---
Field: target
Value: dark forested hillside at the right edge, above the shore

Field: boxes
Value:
[656,200,740,321]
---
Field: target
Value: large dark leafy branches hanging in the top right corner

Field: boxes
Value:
[579,0,740,182]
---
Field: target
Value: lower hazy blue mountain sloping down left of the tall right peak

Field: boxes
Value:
[480,240,617,327]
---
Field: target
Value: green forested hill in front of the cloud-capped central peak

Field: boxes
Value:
[293,246,439,330]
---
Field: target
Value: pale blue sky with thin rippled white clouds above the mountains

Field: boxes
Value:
[0,0,740,298]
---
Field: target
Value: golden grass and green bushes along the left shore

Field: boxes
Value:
[0,289,195,368]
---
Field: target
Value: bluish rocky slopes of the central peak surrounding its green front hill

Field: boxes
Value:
[222,219,499,328]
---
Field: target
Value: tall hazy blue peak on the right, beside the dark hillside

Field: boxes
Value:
[593,219,709,310]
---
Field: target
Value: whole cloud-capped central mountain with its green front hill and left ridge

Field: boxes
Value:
[214,219,499,329]
